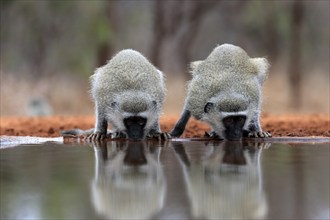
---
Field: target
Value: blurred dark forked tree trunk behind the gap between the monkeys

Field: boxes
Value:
[151,0,219,78]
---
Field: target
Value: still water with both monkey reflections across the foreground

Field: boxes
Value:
[0,141,329,219]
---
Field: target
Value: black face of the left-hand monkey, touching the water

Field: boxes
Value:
[124,116,147,139]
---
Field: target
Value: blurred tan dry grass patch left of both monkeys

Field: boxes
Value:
[0,74,93,116]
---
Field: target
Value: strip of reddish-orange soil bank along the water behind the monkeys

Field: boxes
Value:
[0,114,330,138]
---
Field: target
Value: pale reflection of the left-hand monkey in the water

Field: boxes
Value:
[91,141,166,219]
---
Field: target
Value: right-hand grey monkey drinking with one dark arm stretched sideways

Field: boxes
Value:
[170,44,271,140]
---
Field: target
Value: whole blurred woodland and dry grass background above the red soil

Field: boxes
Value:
[0,0,330,116]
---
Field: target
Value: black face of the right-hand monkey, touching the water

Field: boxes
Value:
[222,115,246,140]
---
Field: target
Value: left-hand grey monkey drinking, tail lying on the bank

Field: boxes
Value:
[62,49,165,140]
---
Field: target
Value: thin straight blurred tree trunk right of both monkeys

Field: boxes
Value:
[289,0,304,109]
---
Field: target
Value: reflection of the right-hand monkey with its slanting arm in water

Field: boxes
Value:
[172,141,269,219]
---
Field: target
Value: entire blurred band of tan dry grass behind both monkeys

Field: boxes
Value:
[0,72,330,116]
